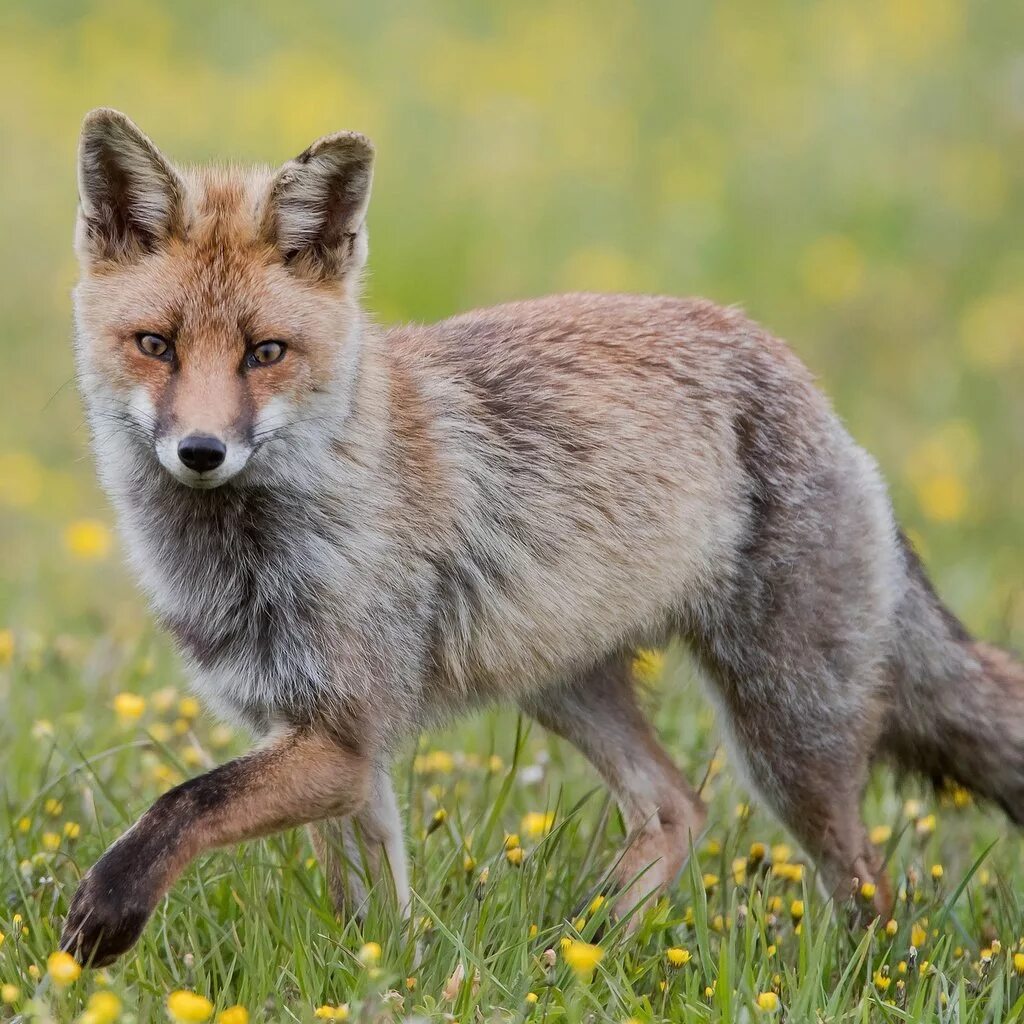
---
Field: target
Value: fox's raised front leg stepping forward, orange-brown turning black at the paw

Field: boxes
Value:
[60,728,372,967]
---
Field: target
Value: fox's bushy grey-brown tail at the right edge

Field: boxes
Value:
[883,538,1024,825]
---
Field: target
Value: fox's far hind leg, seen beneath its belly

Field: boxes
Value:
[522,655,706,929]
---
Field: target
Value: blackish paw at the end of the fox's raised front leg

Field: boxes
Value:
[60,864,151,967]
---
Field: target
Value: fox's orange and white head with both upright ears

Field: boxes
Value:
[75,110,374,488]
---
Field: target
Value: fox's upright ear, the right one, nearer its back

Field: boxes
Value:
[263,131,374,281]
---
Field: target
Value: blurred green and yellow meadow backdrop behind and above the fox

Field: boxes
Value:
[0,0,1024,638]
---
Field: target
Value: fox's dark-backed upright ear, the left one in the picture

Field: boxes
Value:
[78,108,184,261]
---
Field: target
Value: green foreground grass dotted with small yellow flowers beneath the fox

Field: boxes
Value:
[0,634,1024,1022]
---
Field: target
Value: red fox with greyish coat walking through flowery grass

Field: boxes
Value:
[62,110,1024,965]
